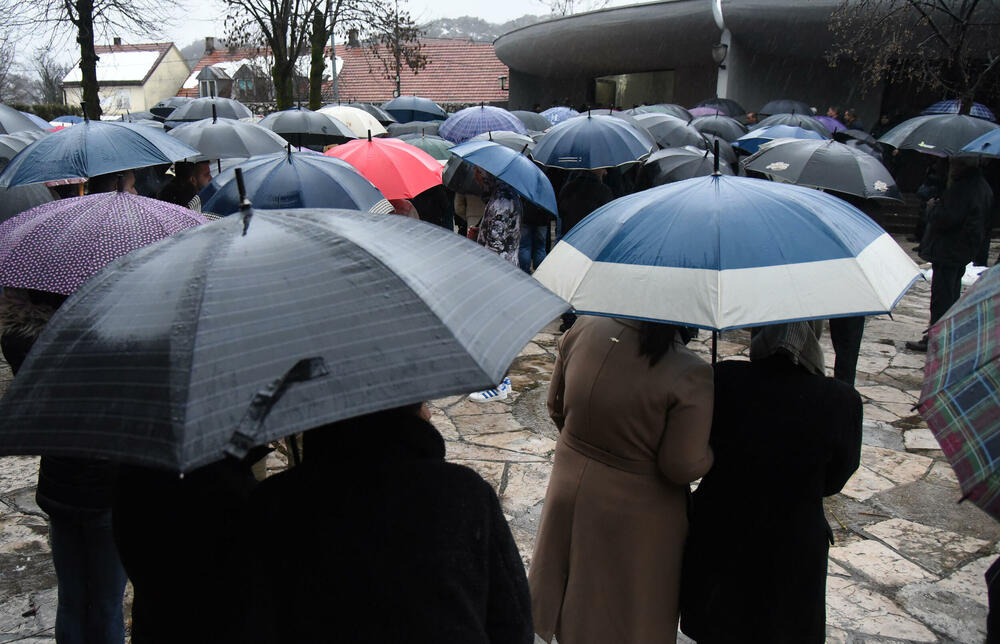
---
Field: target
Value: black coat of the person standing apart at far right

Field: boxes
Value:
[920,168,993,266]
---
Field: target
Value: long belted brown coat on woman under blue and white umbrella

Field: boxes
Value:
[528,316,713,644]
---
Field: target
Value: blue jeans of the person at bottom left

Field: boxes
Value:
[49,510,126,644]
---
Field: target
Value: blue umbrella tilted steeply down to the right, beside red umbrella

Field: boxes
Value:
[451,141,559,217]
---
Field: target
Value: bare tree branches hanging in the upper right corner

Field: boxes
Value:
[827,0,1000,114]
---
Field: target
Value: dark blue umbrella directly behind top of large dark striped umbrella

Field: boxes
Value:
[200,152,392,215]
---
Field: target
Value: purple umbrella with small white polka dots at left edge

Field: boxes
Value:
[0,192,208,295]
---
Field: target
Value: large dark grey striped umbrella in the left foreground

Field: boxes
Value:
[0,210,566,472]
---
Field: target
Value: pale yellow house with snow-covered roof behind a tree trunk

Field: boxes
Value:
[62,38,189,116]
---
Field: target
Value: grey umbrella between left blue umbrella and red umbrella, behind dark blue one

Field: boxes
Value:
[169,118,287,160]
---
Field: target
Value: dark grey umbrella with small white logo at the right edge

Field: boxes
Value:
[878,114,998,157]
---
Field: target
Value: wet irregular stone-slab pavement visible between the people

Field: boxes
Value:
[0,238,1000,644]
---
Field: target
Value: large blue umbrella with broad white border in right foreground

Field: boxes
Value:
[534,176,920,331]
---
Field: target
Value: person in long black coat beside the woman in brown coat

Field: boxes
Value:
[681,322,862,644]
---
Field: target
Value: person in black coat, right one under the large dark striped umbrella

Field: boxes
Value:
[241,405,533,644]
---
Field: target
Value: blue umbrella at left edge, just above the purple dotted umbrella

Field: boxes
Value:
[0,121,198,188]
